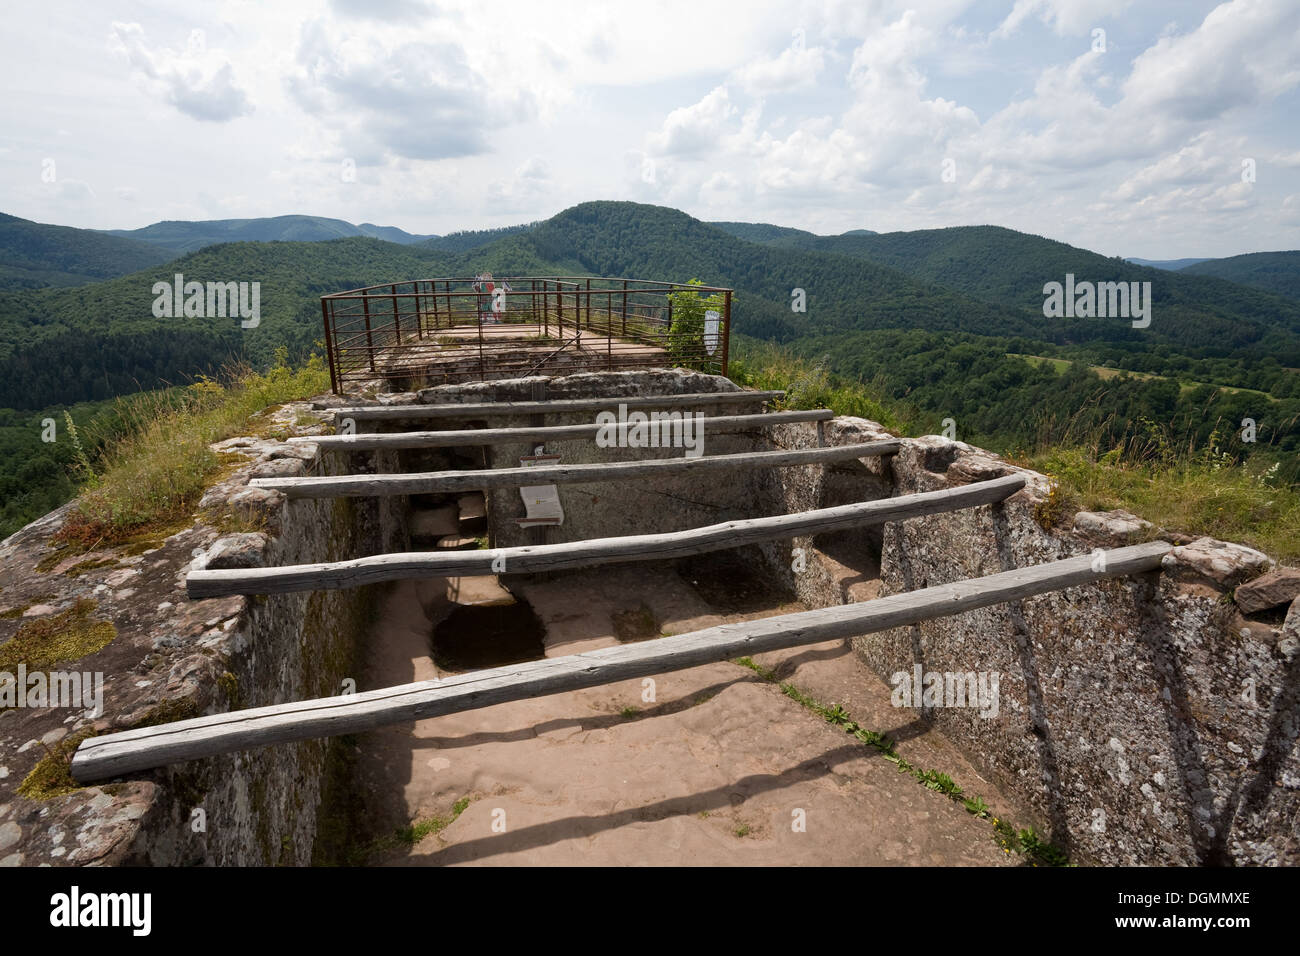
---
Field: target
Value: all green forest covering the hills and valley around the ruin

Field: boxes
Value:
[0,202,1300,546]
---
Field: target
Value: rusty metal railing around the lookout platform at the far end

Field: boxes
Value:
[321,276,732,394]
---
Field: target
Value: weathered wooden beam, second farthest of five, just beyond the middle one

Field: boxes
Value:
[289,408,835,451]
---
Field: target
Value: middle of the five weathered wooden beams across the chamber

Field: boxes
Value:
[248,438,901,498]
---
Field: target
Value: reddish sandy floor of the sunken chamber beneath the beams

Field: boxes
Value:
[345,566,1011,866]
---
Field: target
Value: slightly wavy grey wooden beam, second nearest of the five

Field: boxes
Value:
[185,475,1024,600]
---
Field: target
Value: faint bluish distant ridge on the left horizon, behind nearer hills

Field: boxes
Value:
[100,216,438,255]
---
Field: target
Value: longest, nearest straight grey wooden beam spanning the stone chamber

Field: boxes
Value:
[72,541,1173,783]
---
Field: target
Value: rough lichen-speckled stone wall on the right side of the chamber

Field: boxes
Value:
[763,427,1300,865]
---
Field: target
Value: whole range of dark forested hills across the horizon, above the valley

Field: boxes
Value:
[0,202,1300,408]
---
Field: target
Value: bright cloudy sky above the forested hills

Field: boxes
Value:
[0,0,1300,259]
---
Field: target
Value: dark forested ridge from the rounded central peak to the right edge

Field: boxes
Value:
[527,203,1300,365]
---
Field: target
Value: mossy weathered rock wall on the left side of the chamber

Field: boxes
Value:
[0,403,406,865]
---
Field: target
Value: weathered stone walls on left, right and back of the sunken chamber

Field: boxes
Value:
[0,369,1300,865]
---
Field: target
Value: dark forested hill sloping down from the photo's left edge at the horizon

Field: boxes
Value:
[0,213,174,289]
